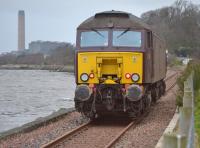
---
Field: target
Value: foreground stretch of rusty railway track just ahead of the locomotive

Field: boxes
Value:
[42,116,147,148]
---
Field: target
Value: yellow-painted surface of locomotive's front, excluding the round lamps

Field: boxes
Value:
[77,52,143,84]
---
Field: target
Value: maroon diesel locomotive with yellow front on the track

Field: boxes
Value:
[74,10,166,119]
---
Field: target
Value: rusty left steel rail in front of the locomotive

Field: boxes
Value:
[41,121,91,148]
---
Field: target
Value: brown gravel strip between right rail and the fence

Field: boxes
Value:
[113,86,177,148]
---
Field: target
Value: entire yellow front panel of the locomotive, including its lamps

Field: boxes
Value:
[77,51,143,85]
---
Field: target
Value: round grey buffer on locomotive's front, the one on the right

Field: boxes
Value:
[126,84,142,101]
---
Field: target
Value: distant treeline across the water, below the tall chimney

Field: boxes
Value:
[0,44,75,65]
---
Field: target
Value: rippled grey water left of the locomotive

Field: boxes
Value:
[0,70,75,133]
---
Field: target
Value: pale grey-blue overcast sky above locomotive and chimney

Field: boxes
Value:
[0,0,200,53]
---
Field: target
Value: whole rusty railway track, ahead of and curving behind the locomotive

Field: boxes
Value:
[42,73,178,148]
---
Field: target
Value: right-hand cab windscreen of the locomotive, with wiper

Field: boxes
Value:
[112,29,142,47]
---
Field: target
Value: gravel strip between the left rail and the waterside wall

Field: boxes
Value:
[0,112,87,148]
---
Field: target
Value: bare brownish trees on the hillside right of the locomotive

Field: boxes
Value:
[141,0,200,58]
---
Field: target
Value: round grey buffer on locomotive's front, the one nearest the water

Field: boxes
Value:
[75,85,92,101]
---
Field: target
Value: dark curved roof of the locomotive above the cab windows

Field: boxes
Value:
[77,10,151,30]
